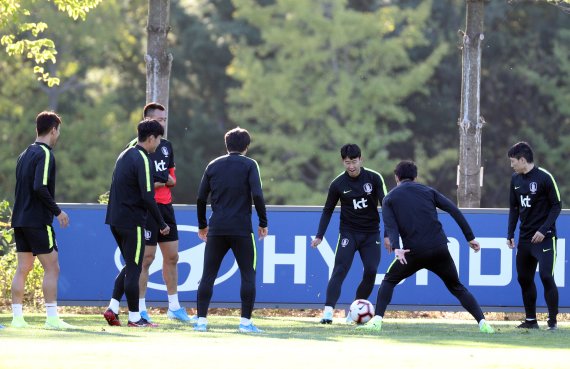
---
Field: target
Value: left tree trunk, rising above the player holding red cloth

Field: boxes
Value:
[145,0,172,137]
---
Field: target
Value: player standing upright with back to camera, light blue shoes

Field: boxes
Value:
[194,127,267,333]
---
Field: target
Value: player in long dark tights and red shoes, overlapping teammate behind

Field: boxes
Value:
[103,120,170,327]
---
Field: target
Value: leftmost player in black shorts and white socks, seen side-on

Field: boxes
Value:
[12,111,74,329]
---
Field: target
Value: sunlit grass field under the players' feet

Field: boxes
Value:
[0,314,570,369]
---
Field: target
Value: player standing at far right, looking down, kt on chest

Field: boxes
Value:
[507,142,562,330]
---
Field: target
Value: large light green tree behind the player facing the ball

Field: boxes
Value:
[228,0,447,204]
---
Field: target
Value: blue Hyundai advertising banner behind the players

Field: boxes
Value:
[54,204,570,309]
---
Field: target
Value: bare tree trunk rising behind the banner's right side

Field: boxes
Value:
[457,0,485,208]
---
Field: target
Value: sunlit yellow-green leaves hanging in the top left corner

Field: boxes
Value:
[0,0,101,87]
